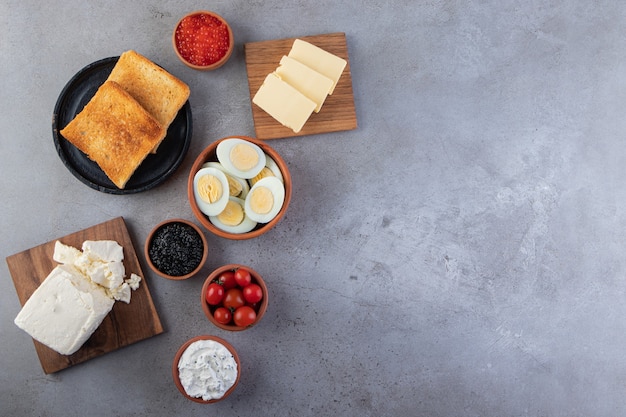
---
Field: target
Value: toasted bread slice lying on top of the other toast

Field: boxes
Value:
[61,81,167,189]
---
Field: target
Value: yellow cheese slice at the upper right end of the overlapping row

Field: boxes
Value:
[288,39,348,94]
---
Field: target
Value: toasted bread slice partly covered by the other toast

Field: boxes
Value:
[108,50,189,129]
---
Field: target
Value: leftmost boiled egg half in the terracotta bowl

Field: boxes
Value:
[193,167,229,216]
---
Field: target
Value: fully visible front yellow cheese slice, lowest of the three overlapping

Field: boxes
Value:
[252,73,316,133]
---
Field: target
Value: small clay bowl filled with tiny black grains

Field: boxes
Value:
[144,219,209,280]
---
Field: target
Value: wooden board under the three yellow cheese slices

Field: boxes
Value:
[244,33,357,139]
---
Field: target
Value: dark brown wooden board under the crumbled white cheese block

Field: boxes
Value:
[6,217,163,374]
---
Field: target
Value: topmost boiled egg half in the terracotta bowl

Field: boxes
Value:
[216,138,265,179]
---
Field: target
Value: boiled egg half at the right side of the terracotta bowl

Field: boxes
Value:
[244,176,285,223]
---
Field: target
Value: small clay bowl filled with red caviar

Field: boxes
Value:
[172,10,235,71]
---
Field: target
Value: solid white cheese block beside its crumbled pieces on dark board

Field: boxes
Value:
[14,265,115,355]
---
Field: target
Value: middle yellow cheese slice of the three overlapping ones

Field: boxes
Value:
[275,56,334,113]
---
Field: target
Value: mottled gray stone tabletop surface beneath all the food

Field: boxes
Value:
[0,0,626,417]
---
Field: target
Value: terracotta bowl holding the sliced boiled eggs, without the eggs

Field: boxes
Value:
[187,136,292,240]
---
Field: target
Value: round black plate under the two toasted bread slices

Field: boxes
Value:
[52,57,192,194]
